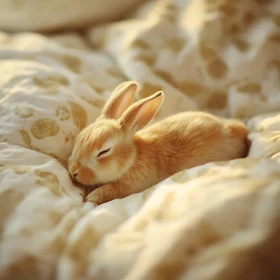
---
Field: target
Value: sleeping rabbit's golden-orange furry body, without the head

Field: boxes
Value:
[114,112,248,192]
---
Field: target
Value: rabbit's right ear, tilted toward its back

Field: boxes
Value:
[119,91,163,133]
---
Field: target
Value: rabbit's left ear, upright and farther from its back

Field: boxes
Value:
[100,81,138,119]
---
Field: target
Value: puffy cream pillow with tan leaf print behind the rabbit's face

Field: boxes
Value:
[0,33,125,163]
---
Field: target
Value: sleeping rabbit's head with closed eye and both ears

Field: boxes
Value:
[68,81,163,186]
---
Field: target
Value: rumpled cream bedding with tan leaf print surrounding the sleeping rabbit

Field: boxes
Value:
[0,0,280,280]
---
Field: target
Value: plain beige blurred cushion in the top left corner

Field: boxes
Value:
[0,0,140,31]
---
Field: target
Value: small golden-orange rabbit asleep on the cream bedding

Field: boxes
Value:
[68,81,248,205]
